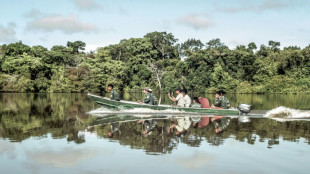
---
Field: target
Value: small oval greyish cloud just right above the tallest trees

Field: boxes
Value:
[177,14,213,30]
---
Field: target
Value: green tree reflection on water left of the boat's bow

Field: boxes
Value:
[0,93,94,143]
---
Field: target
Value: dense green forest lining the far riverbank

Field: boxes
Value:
[0,32,310,93]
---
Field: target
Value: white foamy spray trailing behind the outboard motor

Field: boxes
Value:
[264,106,310,121]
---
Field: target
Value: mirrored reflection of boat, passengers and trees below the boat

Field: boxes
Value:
[83,115,310,154]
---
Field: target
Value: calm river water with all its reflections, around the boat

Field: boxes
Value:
[0,93,310,174]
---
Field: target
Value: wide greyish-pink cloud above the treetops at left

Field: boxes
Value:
[27,15,97,34]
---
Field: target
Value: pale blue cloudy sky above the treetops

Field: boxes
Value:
[0,0,310,51]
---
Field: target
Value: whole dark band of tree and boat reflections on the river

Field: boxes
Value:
[0,93,310,154]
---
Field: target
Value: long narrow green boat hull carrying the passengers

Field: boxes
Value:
[87,93,249,115]
